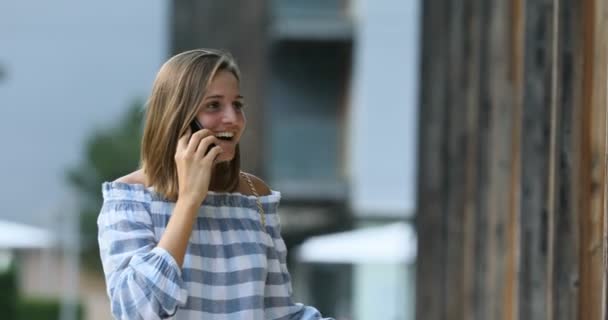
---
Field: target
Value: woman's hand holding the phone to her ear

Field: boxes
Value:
[175,129,222,206]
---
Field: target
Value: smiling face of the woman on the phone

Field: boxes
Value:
[196,71,246,163]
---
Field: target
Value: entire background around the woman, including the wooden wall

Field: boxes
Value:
[0,0,608,320]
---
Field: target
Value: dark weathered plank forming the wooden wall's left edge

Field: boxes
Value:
[416,0,449,320]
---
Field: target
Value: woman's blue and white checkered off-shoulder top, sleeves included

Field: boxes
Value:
[97,182,332,320]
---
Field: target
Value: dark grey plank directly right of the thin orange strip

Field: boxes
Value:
[516,0,554,320]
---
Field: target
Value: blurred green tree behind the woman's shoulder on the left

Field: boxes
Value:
[66,101,143,270]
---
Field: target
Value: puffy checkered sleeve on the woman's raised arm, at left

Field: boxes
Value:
[97,182,188,319]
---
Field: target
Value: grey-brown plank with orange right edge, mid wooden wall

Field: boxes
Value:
[486,0,523,319]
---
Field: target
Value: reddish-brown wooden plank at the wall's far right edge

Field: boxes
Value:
[578,0,608,319]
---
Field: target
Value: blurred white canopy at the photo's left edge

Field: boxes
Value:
[0,220,55,249]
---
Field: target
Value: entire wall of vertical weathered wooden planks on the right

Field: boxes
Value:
[416,0,608,320]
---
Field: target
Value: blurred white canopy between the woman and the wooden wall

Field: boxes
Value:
[295,222,417,264]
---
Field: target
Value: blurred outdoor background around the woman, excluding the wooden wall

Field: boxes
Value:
[0,0,420,319]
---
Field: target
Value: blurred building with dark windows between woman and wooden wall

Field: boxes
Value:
[171,0,420,319]
